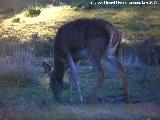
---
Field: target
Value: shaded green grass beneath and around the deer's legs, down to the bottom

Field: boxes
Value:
[0,63,160,120]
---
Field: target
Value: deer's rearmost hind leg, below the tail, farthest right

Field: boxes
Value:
[107,55,129,103]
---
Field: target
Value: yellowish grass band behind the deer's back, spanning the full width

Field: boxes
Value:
[0,6,160,40]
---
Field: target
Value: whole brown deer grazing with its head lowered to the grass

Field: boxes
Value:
[43,19,129,103]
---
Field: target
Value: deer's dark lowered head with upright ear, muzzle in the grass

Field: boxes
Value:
[42,62,63,101]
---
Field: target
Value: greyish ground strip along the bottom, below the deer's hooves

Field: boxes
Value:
[0,103,160,120]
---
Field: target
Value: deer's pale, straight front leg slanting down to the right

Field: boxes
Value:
[67,51,83,103]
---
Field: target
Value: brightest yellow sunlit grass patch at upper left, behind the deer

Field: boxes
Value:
[2,6,77,39]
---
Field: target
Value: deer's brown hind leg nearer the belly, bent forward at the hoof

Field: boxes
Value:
[88,53,105,102]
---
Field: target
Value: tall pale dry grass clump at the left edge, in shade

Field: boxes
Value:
[0,44,36,86]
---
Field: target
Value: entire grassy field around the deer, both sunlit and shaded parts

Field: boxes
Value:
[0,0,160,120]
